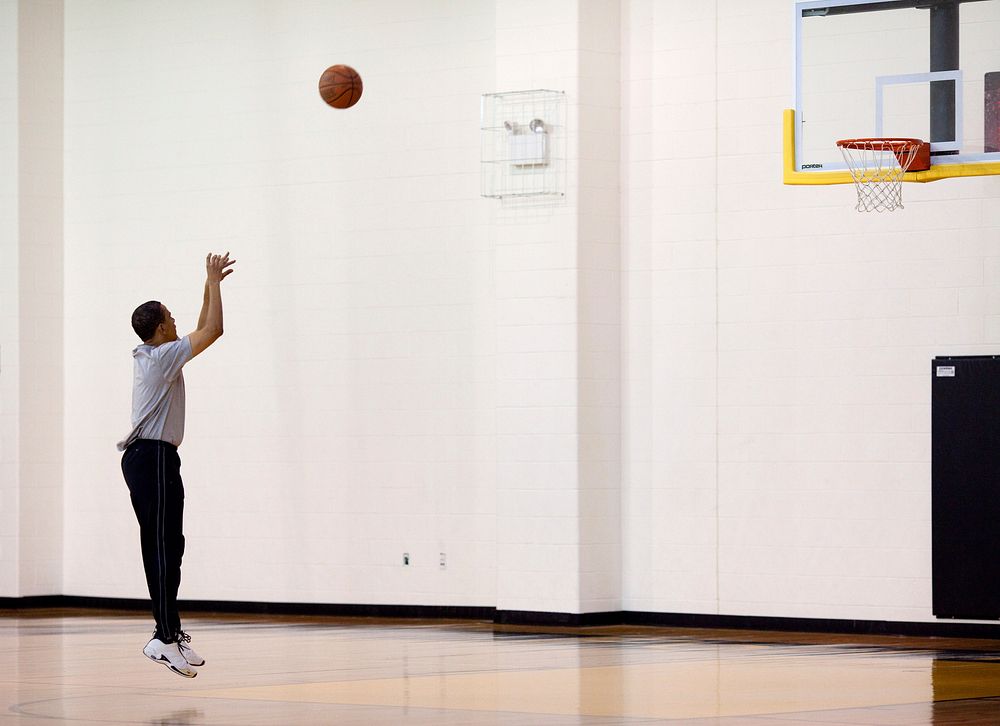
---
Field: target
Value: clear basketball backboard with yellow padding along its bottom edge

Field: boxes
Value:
[785,0,1000,184]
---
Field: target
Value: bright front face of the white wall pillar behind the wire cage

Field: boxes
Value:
[491,0,580,619]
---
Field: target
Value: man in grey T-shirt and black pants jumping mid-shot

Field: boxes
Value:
[118,252,236,678]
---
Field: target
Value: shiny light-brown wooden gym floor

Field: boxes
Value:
[0,611,1000,726]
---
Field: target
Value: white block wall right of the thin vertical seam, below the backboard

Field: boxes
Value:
[717,2,1000,620]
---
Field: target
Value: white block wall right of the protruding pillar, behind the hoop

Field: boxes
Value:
[623,0,1000,621]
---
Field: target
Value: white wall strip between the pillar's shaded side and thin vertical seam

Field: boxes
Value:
[622,0,720,613]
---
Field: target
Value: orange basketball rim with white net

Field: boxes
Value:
[837,138,930,212]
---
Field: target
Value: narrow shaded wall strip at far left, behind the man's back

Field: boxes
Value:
[16,0,63,597]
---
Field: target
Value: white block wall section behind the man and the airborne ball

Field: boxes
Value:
[65,0,496,605]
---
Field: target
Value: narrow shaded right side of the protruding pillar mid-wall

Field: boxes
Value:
[576,0,622,613]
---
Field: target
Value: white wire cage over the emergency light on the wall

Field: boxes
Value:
[480,89,566,199]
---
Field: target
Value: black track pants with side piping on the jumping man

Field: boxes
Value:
[122,439,184,642]
